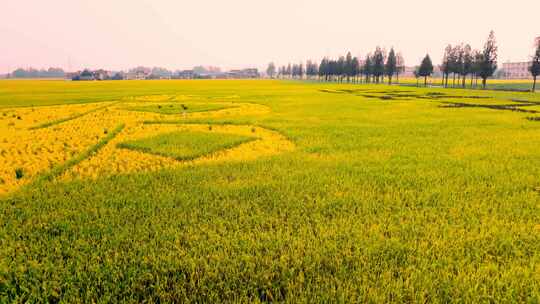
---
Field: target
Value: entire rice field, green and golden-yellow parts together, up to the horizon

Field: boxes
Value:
[0,80,540,303]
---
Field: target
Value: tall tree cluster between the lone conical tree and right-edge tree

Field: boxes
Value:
[440,31,498,88]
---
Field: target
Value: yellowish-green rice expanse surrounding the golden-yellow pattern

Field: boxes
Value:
[0,81,540,303]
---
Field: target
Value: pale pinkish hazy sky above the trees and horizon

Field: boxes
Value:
[0,0,540,72]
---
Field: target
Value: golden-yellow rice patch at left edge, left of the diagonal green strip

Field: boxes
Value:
[0,105,118,195]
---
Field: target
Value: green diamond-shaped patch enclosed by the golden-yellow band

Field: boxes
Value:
[117,132,256,160]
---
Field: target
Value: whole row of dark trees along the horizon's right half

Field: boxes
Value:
[266,31,540,91]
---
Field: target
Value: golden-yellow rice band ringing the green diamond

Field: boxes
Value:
[62,124,294,179]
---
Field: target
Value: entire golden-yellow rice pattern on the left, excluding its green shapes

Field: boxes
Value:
[0,95,293,195]
